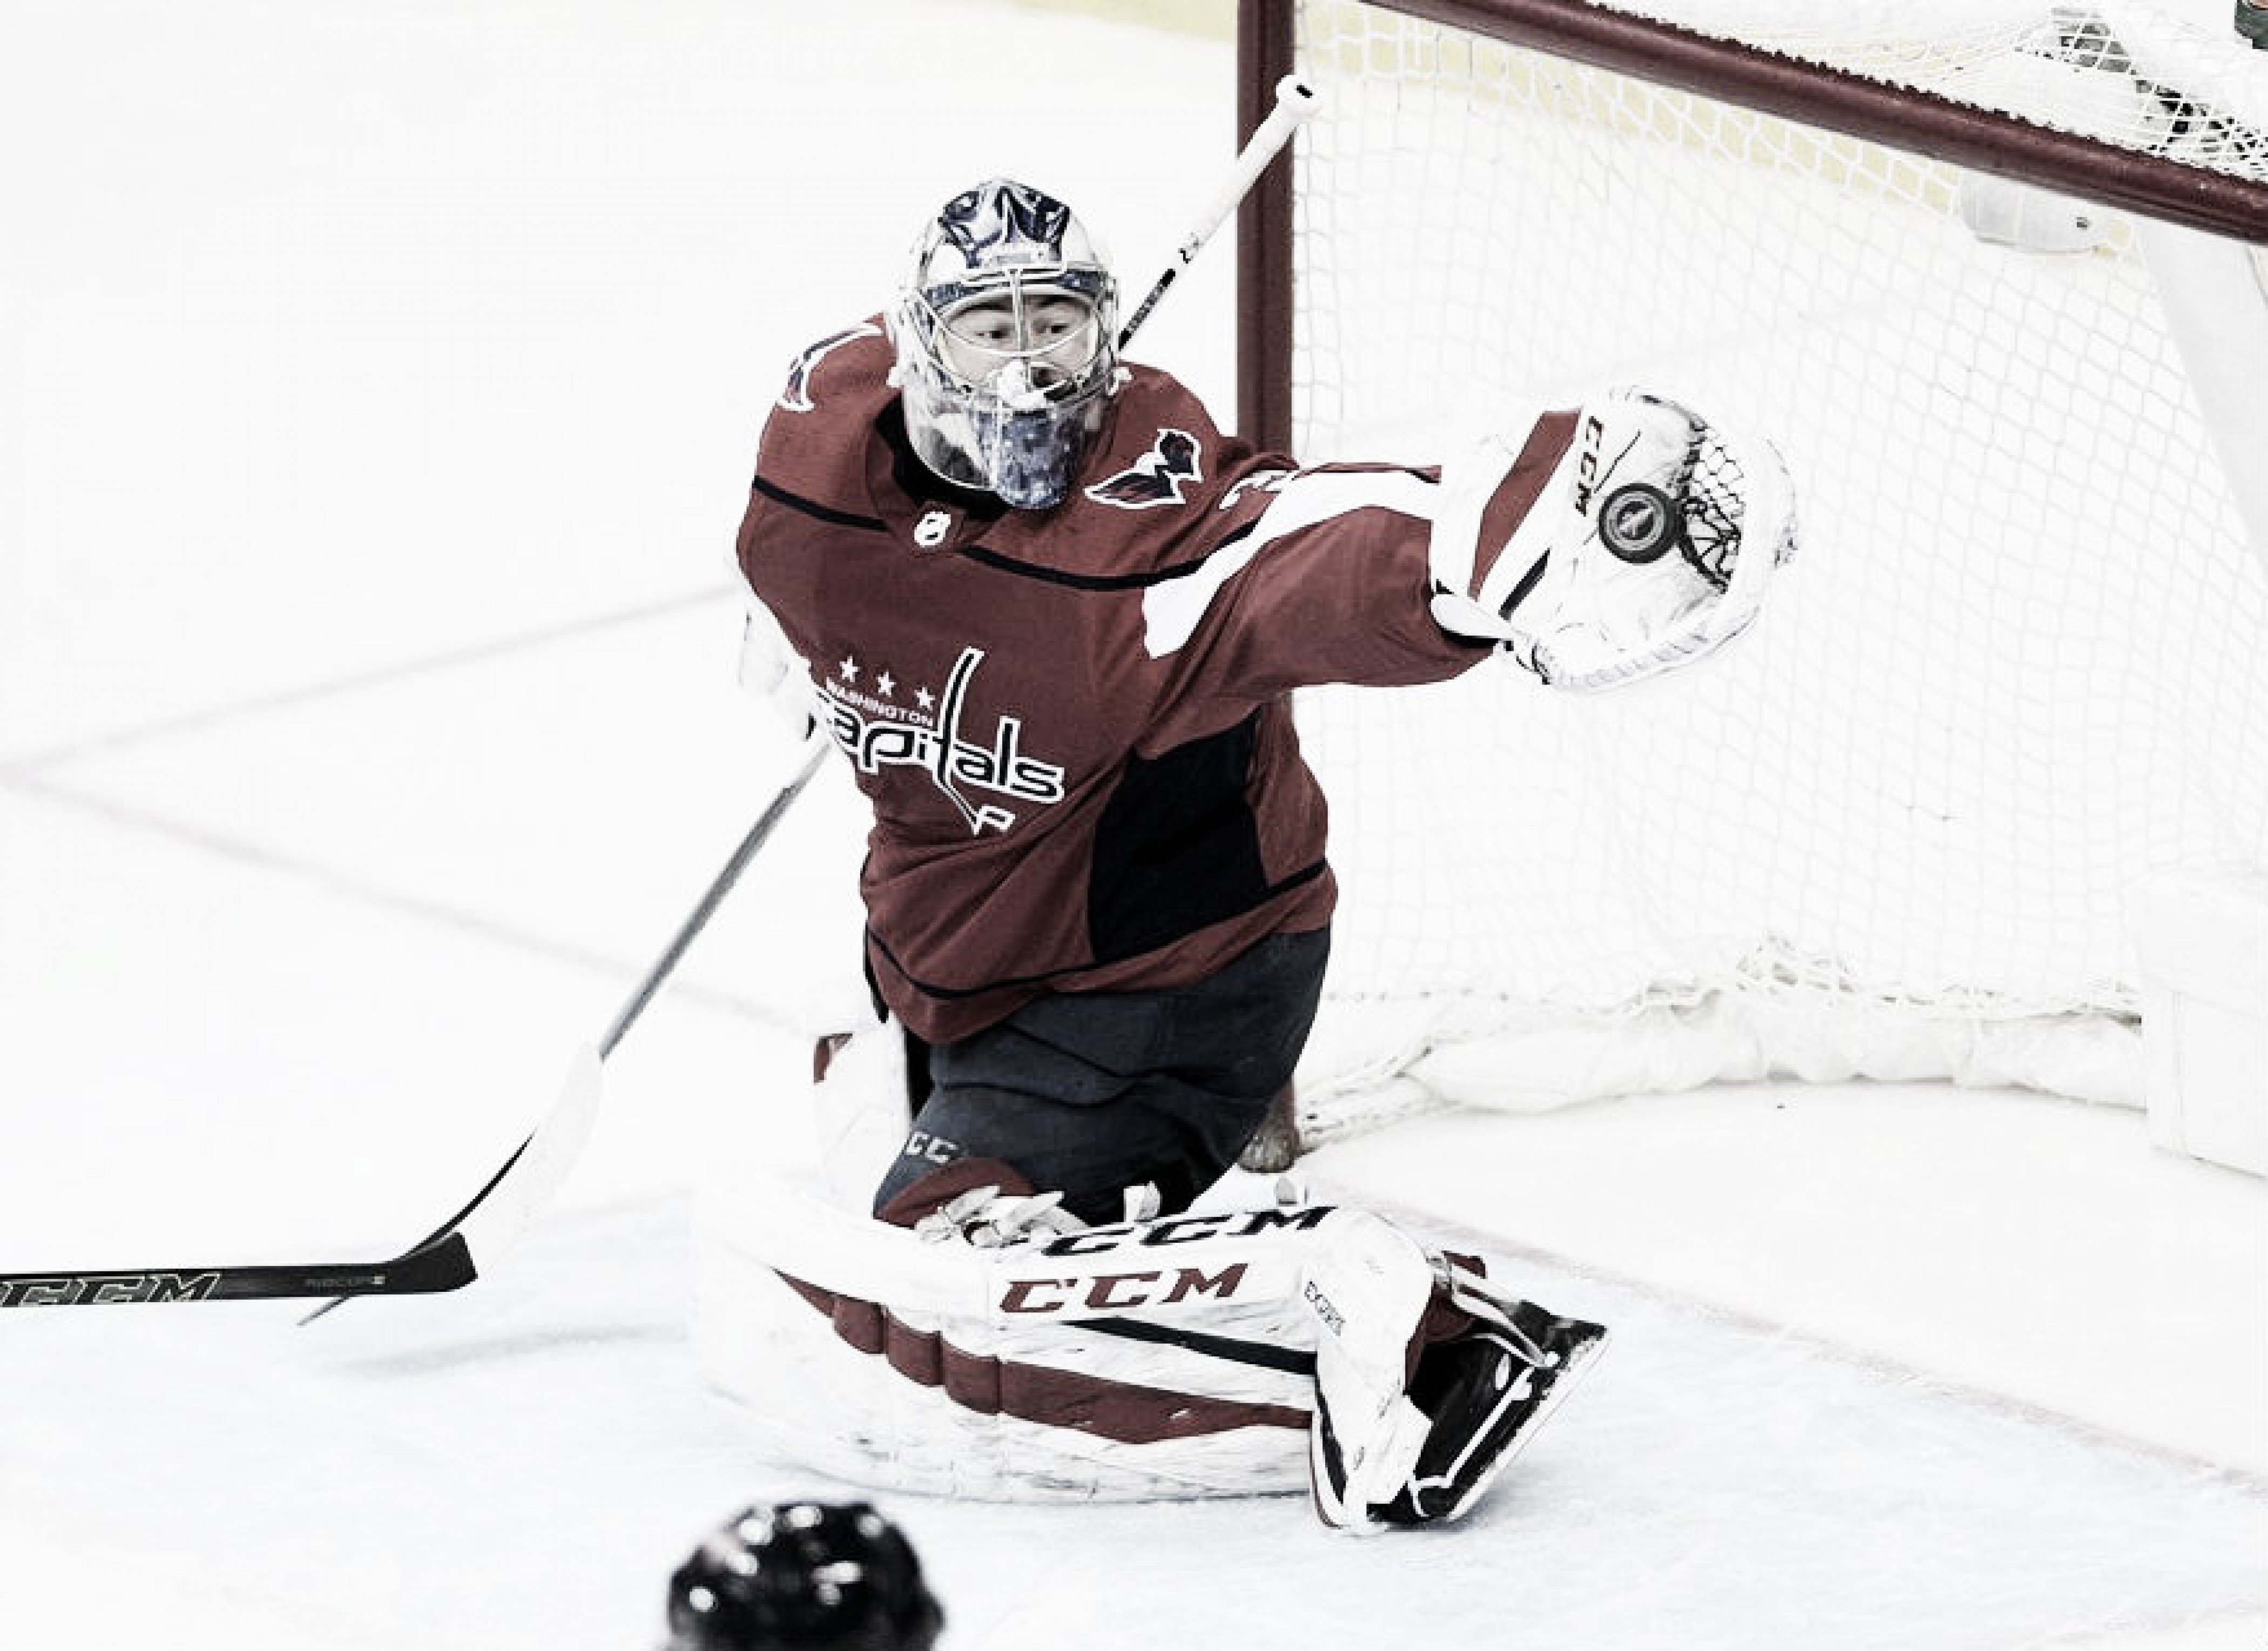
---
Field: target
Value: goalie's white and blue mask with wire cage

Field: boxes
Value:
[892,179,1118,510]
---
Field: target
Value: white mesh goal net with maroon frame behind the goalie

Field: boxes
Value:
[1240,0,2268,1141]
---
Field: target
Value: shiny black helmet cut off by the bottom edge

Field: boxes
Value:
[667,1501,946,1651]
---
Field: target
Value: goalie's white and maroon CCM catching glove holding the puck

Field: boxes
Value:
[1431,390,1794,692]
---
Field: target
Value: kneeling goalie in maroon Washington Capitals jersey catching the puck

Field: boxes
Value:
[696,179,1792,1531]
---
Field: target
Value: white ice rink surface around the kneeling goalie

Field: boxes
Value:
[0,0,2268,1651]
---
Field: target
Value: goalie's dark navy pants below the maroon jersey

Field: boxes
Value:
[873,930,1331,1222]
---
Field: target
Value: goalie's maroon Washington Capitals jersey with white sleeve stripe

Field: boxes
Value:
[739,320,1486,1041]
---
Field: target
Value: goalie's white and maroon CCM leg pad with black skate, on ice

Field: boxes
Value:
[696,1161,1599,1531]
